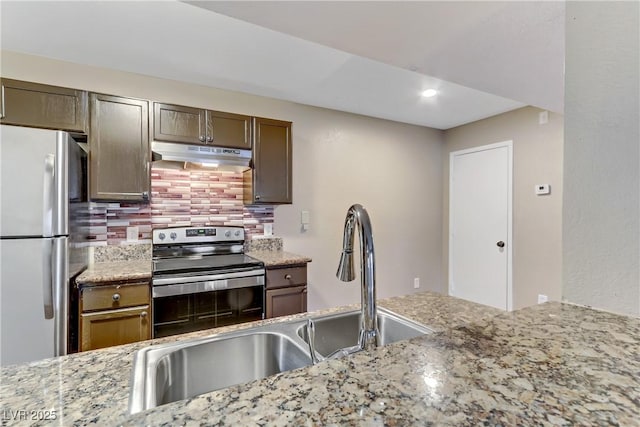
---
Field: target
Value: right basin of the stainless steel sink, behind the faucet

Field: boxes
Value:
[297,308,433,357]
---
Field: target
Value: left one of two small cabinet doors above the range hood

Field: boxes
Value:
[153,102,207,144]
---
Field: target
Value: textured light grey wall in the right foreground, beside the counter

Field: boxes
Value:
[563,1,640,316]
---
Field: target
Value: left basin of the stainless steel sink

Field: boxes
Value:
[129,328,311,413]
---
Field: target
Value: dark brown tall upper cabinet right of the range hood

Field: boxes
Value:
[244,117,292,204]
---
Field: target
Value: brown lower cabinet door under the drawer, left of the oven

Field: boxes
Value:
[80,305,151,351]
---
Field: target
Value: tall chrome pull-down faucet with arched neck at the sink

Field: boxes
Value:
[336,204,380,350]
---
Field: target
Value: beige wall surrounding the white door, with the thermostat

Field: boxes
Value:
[442,107,564,309]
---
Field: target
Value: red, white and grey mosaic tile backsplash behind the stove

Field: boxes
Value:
[90,164,273,246]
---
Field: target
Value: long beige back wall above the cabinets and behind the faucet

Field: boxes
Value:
[0,52,443,310]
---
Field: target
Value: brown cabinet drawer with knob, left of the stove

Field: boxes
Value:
[80,283,150,312]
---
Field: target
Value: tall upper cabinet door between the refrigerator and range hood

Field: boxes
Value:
[89,93,149,201]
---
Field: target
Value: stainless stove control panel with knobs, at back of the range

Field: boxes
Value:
[152,227,244,245]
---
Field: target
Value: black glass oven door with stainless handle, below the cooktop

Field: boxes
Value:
[153,270,265,338]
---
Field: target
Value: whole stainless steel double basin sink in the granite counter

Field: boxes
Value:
[129,308,432,413]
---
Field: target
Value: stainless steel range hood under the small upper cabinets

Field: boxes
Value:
[151,141,251,169]
